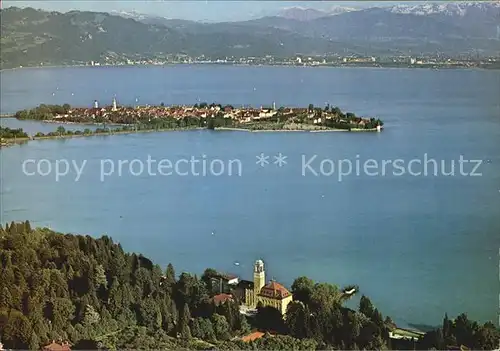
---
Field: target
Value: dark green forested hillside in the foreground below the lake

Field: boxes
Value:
[0,222,499,350]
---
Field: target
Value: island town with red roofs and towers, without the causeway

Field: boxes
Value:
[15,98,383,131]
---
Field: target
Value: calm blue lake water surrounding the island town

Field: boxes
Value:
[0,66,500,324]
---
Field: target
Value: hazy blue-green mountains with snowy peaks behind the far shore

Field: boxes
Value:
[0,2,500,68]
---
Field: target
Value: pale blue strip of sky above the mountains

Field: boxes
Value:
[1,0,450,22]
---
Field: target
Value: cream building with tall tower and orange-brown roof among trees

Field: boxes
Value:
[241,260,293,314]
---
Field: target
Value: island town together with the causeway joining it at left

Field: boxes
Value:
[0,98,384,146]
